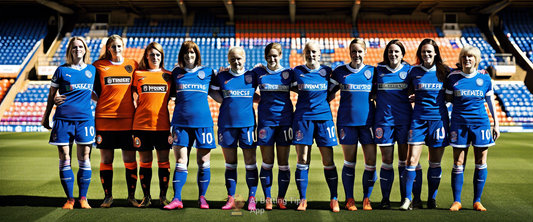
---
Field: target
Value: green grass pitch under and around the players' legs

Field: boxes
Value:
[0,133,533,222]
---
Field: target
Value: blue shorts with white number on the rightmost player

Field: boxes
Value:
[450,123,495,148]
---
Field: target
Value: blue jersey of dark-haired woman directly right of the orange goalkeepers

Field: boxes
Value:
[170,66,215,128]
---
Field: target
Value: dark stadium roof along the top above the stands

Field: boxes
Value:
[0,0,532,18]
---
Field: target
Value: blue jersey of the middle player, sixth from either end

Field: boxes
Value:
[254,68,296,126]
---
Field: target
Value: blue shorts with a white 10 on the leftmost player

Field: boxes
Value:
[48,119,95,146]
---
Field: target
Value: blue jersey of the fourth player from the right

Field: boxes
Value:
[330,64,375,126]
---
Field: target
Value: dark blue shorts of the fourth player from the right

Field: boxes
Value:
[337,125,374,145]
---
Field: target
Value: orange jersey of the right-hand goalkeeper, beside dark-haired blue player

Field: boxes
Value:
[132,69,172,131]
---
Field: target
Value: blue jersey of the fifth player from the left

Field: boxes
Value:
[213,70,257,128]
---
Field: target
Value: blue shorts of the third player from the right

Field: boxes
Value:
[374,125,409,146]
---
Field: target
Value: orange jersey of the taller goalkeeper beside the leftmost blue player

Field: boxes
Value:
[93,59,138,118]
